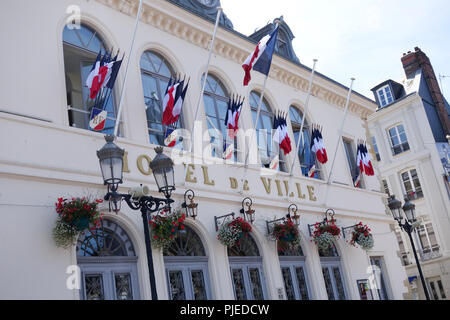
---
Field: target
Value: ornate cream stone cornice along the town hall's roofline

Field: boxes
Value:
[96,0,377,119]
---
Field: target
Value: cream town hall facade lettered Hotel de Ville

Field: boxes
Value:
[0,0,407,300]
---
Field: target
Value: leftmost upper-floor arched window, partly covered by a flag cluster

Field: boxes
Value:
[63,25,116,134]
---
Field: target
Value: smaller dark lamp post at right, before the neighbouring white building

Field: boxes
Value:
[388,195,430,300]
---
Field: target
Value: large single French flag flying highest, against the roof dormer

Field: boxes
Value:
[242,26,279,86]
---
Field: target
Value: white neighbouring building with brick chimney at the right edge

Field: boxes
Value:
[369,48,450,300]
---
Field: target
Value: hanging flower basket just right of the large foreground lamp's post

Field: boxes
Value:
[149,210,186,249]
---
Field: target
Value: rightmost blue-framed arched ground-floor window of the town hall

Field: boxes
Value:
[319,245,346,300]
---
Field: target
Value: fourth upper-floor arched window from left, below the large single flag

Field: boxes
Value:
[250,91,287,172]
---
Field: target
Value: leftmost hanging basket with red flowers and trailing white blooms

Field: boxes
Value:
[53,197,103,249]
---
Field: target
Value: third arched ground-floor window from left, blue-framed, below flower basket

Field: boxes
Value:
[228,235,267,300]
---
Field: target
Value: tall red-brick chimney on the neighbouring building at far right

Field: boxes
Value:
[401,47,450,135]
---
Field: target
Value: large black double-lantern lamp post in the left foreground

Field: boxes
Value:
[97,135,175,300]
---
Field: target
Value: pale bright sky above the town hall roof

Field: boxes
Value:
[221,0,450,100]
